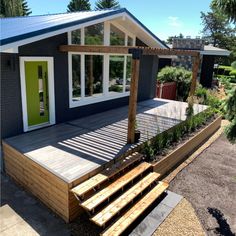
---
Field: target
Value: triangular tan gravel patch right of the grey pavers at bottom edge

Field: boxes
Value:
[153,198,205,236]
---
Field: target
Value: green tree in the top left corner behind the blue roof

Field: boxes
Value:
[0,0,32,17]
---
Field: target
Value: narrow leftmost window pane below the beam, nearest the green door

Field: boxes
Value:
[72,55,81,101]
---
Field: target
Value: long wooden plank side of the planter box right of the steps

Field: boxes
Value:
[152,116,222,176]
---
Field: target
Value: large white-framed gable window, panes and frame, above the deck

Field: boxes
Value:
[68,22,135,107]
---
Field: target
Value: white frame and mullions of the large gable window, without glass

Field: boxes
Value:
[68,21,136,108]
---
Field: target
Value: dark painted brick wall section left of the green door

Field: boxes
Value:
[1,53,23,138]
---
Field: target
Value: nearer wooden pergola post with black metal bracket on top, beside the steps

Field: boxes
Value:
[127,48,142,144]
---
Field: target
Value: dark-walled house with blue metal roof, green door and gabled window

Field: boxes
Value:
[1,9,168,142]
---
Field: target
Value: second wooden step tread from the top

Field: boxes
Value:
[81,162,151,211]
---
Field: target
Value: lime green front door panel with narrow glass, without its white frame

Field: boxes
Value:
[25,61,49,126]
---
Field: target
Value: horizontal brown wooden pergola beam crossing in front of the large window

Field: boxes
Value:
[59,45,130,54]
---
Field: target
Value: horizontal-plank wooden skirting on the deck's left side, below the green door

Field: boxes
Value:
[3,142,82,222]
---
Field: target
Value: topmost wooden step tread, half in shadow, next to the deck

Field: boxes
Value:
[71,153,142,198]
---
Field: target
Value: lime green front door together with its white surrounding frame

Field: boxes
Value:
[21,58,55,131]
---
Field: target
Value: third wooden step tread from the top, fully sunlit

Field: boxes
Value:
[91,172,160,226]
